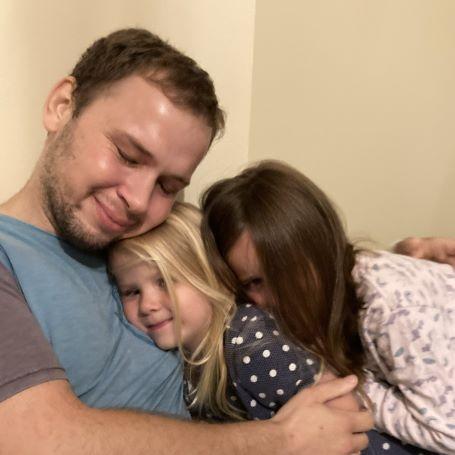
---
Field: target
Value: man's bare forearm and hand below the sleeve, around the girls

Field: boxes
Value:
[0,377,372,455]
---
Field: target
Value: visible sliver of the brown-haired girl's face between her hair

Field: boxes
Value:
[227,230,273,308]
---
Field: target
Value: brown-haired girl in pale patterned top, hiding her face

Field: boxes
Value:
[202,161,455,453]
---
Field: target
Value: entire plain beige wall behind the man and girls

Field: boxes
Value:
[0,0,455,244]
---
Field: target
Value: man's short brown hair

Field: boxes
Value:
[71,28,224,138]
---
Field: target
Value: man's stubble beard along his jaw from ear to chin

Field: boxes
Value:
[40,121,113,251]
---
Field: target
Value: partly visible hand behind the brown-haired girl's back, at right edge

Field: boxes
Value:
[393,237,455,267]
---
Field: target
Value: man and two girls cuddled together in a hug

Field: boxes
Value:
[0,29,455,455]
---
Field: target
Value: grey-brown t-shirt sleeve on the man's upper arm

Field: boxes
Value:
[0,263,66,402]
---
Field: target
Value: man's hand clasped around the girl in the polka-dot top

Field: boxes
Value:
[272,376,373,455]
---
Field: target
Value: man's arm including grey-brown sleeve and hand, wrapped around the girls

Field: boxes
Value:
[0,266,372,455]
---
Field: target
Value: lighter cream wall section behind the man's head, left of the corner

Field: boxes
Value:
[0,0,255,201]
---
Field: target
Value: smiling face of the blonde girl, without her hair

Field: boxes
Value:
[110,252,212,352]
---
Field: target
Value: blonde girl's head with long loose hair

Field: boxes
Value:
[109,203,241,419]
